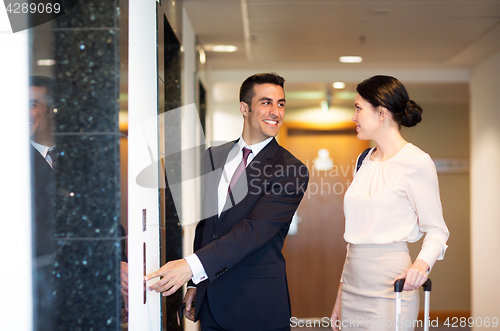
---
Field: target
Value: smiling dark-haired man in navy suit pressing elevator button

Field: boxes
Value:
[146,73,309,331]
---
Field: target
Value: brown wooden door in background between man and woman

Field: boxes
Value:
[282,126,368,318]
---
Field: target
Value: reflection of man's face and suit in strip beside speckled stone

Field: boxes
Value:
[29,76,55,330]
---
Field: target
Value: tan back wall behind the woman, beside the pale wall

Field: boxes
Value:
[403,103,471,316]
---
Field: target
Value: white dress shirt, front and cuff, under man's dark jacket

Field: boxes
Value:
[184,137,273,284]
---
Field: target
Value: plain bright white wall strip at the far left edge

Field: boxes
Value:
[0,9,33,331]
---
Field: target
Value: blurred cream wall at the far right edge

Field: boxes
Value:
[470,52,500,329]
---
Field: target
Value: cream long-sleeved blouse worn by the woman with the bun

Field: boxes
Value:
[344,143,450,268]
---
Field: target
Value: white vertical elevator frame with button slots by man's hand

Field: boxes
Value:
[128,0,161,331]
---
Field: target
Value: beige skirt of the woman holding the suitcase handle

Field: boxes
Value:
[338,242,419,331]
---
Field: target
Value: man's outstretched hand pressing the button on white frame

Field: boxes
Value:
[144,259,193,296]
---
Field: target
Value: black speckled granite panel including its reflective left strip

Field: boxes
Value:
[28,0,127,331]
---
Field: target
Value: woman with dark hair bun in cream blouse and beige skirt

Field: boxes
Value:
[332,76,449,331]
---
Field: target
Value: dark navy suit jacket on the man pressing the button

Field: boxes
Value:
[194,139,309,331]
